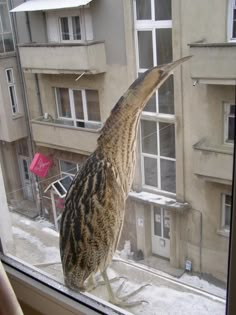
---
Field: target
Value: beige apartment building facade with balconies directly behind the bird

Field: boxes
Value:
[8,0,236,281]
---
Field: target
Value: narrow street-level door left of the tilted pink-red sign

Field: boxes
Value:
[19,156,34,200]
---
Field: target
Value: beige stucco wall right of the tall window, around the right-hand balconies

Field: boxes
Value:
[173,0,231,281]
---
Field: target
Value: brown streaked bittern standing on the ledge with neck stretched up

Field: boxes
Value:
[60,57,189,306]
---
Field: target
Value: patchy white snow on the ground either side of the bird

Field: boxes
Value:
[9,213,225,315]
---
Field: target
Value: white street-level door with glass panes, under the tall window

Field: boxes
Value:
[152,206,170,258]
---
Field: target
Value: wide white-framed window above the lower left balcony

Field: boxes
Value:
[55,88,101,129]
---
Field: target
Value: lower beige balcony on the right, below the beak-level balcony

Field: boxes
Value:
[193,139,233,185]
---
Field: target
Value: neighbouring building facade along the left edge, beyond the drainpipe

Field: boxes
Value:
[0,0,35,212]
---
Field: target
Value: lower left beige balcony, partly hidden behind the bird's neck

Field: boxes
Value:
[31,118,99,155]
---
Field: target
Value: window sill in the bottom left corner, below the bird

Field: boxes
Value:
[0,255,131,315]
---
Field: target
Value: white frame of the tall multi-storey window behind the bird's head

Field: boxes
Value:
[133,0,176,196]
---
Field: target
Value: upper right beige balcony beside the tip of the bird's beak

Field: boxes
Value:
[189,43,236,85]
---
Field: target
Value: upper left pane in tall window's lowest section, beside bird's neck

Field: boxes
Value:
[141,120,157,154]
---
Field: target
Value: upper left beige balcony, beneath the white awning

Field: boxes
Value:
[19,42,106,74]
